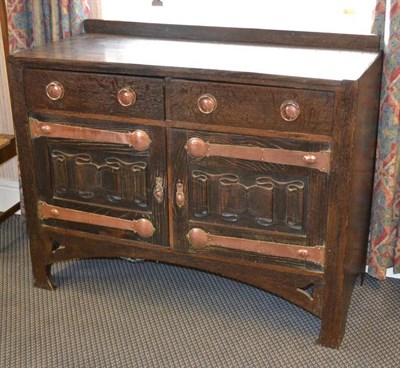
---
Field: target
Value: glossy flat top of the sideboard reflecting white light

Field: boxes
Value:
[12,22,380,81]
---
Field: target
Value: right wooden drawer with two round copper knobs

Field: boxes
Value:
[167,79,334,134]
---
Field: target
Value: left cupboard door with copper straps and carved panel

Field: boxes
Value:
[29,117,168,245]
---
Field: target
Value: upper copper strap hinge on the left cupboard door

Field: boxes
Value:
[29,118,151,151]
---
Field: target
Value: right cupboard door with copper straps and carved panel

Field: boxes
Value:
[169,129,330,268]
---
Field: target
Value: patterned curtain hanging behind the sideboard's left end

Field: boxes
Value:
[6,0,90,52]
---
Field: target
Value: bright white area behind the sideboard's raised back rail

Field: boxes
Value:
[98,0,376,34]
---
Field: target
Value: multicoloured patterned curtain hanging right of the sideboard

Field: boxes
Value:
[368,0,400,280]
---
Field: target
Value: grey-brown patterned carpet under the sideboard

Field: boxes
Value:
[0,216,400,368]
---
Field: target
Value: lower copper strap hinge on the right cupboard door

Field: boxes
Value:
[186,228,325,265]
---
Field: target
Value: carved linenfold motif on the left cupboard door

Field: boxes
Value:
[51,150,148,207]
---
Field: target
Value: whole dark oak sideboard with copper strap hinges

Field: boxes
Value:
[9,20,382,348]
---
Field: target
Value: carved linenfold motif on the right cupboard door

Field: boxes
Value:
[191,170,305,229]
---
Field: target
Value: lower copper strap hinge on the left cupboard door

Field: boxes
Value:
[38,201,155,238]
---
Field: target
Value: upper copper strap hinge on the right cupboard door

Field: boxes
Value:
[185,138,331,173]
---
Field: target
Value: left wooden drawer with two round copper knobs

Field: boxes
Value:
[24,69,164,120]
